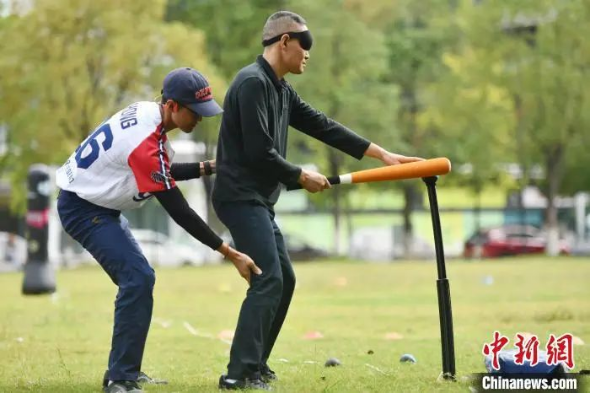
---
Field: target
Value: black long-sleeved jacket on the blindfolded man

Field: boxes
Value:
[213,56,370,207]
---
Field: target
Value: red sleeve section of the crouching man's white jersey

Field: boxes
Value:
[127,124,176,192]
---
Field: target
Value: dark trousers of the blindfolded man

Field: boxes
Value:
[214,201,295,379]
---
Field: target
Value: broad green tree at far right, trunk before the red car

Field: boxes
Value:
[464,0,590,254]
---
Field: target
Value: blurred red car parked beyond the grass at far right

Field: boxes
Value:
[463,225,571,258]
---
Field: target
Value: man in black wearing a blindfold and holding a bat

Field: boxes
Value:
[213,11,421,390]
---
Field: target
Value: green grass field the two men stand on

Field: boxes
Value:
[0,258,590,392]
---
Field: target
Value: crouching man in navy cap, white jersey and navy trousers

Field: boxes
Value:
[56,68,262,393]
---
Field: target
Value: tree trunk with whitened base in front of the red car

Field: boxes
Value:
[545,144,564,256]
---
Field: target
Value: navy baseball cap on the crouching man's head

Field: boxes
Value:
[162,67,223,117]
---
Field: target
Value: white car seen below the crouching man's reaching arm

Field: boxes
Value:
[131,229,203,267]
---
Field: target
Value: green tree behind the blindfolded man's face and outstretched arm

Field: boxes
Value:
[288,0,397,254]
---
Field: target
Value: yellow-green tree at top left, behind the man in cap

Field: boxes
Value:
[0,0,224,209]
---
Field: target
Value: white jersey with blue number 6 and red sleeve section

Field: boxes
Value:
[56,101,176,210]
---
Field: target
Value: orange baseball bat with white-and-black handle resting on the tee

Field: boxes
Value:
[288,157,451,190]
